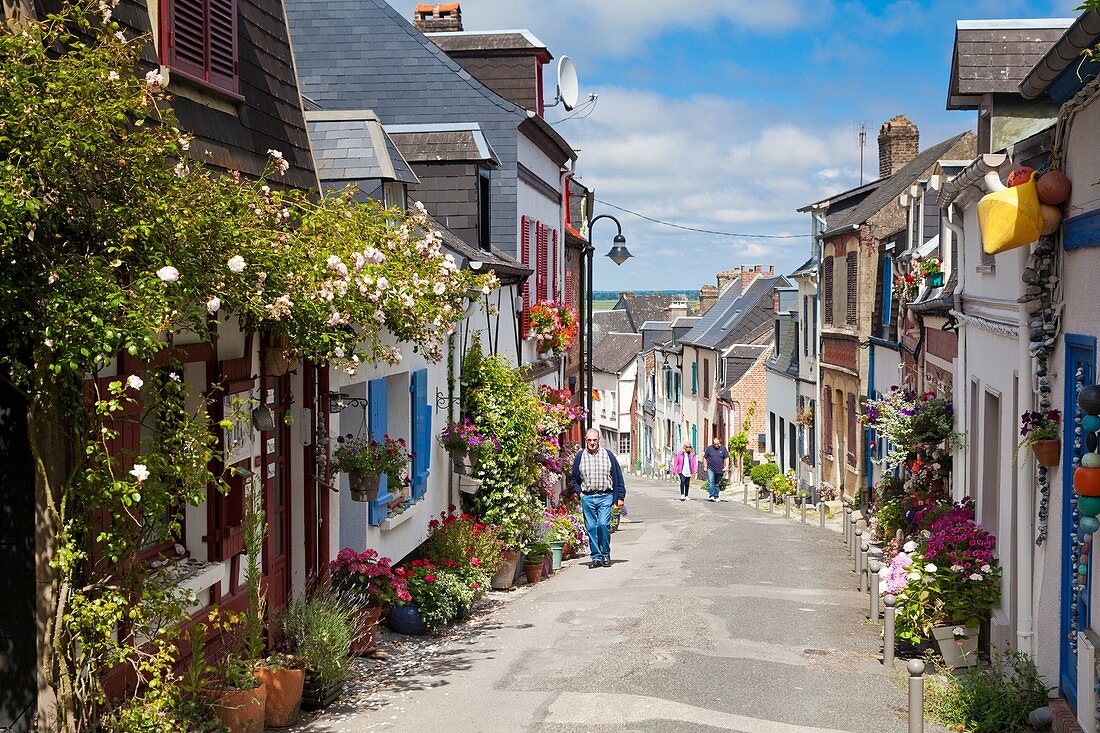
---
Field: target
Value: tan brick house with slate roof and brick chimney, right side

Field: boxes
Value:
[800,116,975,508]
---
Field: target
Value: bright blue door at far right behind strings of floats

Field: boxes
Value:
[1058,333,1097,708]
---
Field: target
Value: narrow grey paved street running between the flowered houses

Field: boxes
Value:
[303,477,946,733]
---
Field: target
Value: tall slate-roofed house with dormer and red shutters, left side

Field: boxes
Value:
[286,0,576,376]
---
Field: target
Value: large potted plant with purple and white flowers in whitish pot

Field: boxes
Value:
[886,499,1001,667]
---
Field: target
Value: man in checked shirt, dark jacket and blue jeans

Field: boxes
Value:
[573,428,626,568]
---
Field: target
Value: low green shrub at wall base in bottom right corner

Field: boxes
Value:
[926,652,1047,733]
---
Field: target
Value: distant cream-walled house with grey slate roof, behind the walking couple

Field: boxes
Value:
[678,267,789,471]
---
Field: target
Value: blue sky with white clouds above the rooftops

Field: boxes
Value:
[388,0,1080,291]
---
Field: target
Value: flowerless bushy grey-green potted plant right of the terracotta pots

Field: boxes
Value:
[282,586,362,710]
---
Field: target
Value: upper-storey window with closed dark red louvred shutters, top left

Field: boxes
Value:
[161,0,239,96]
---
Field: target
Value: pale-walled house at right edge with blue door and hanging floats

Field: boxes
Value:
[939,10,1100,717]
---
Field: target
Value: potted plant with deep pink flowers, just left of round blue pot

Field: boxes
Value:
[329,547,411,655]
